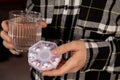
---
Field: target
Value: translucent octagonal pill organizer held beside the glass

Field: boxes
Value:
[28,41,62,72]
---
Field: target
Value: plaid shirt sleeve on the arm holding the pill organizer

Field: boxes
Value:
[81,37,120,72]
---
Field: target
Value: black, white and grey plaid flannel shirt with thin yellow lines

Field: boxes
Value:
[26,0,120,80]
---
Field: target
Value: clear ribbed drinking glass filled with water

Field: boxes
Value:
[8,10,42,52]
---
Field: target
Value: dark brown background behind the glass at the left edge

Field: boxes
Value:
[0,0,30,80]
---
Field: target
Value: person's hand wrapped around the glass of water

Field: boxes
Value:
[0,20,47,55]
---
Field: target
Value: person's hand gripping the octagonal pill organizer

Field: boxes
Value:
[42,40,87,76]
